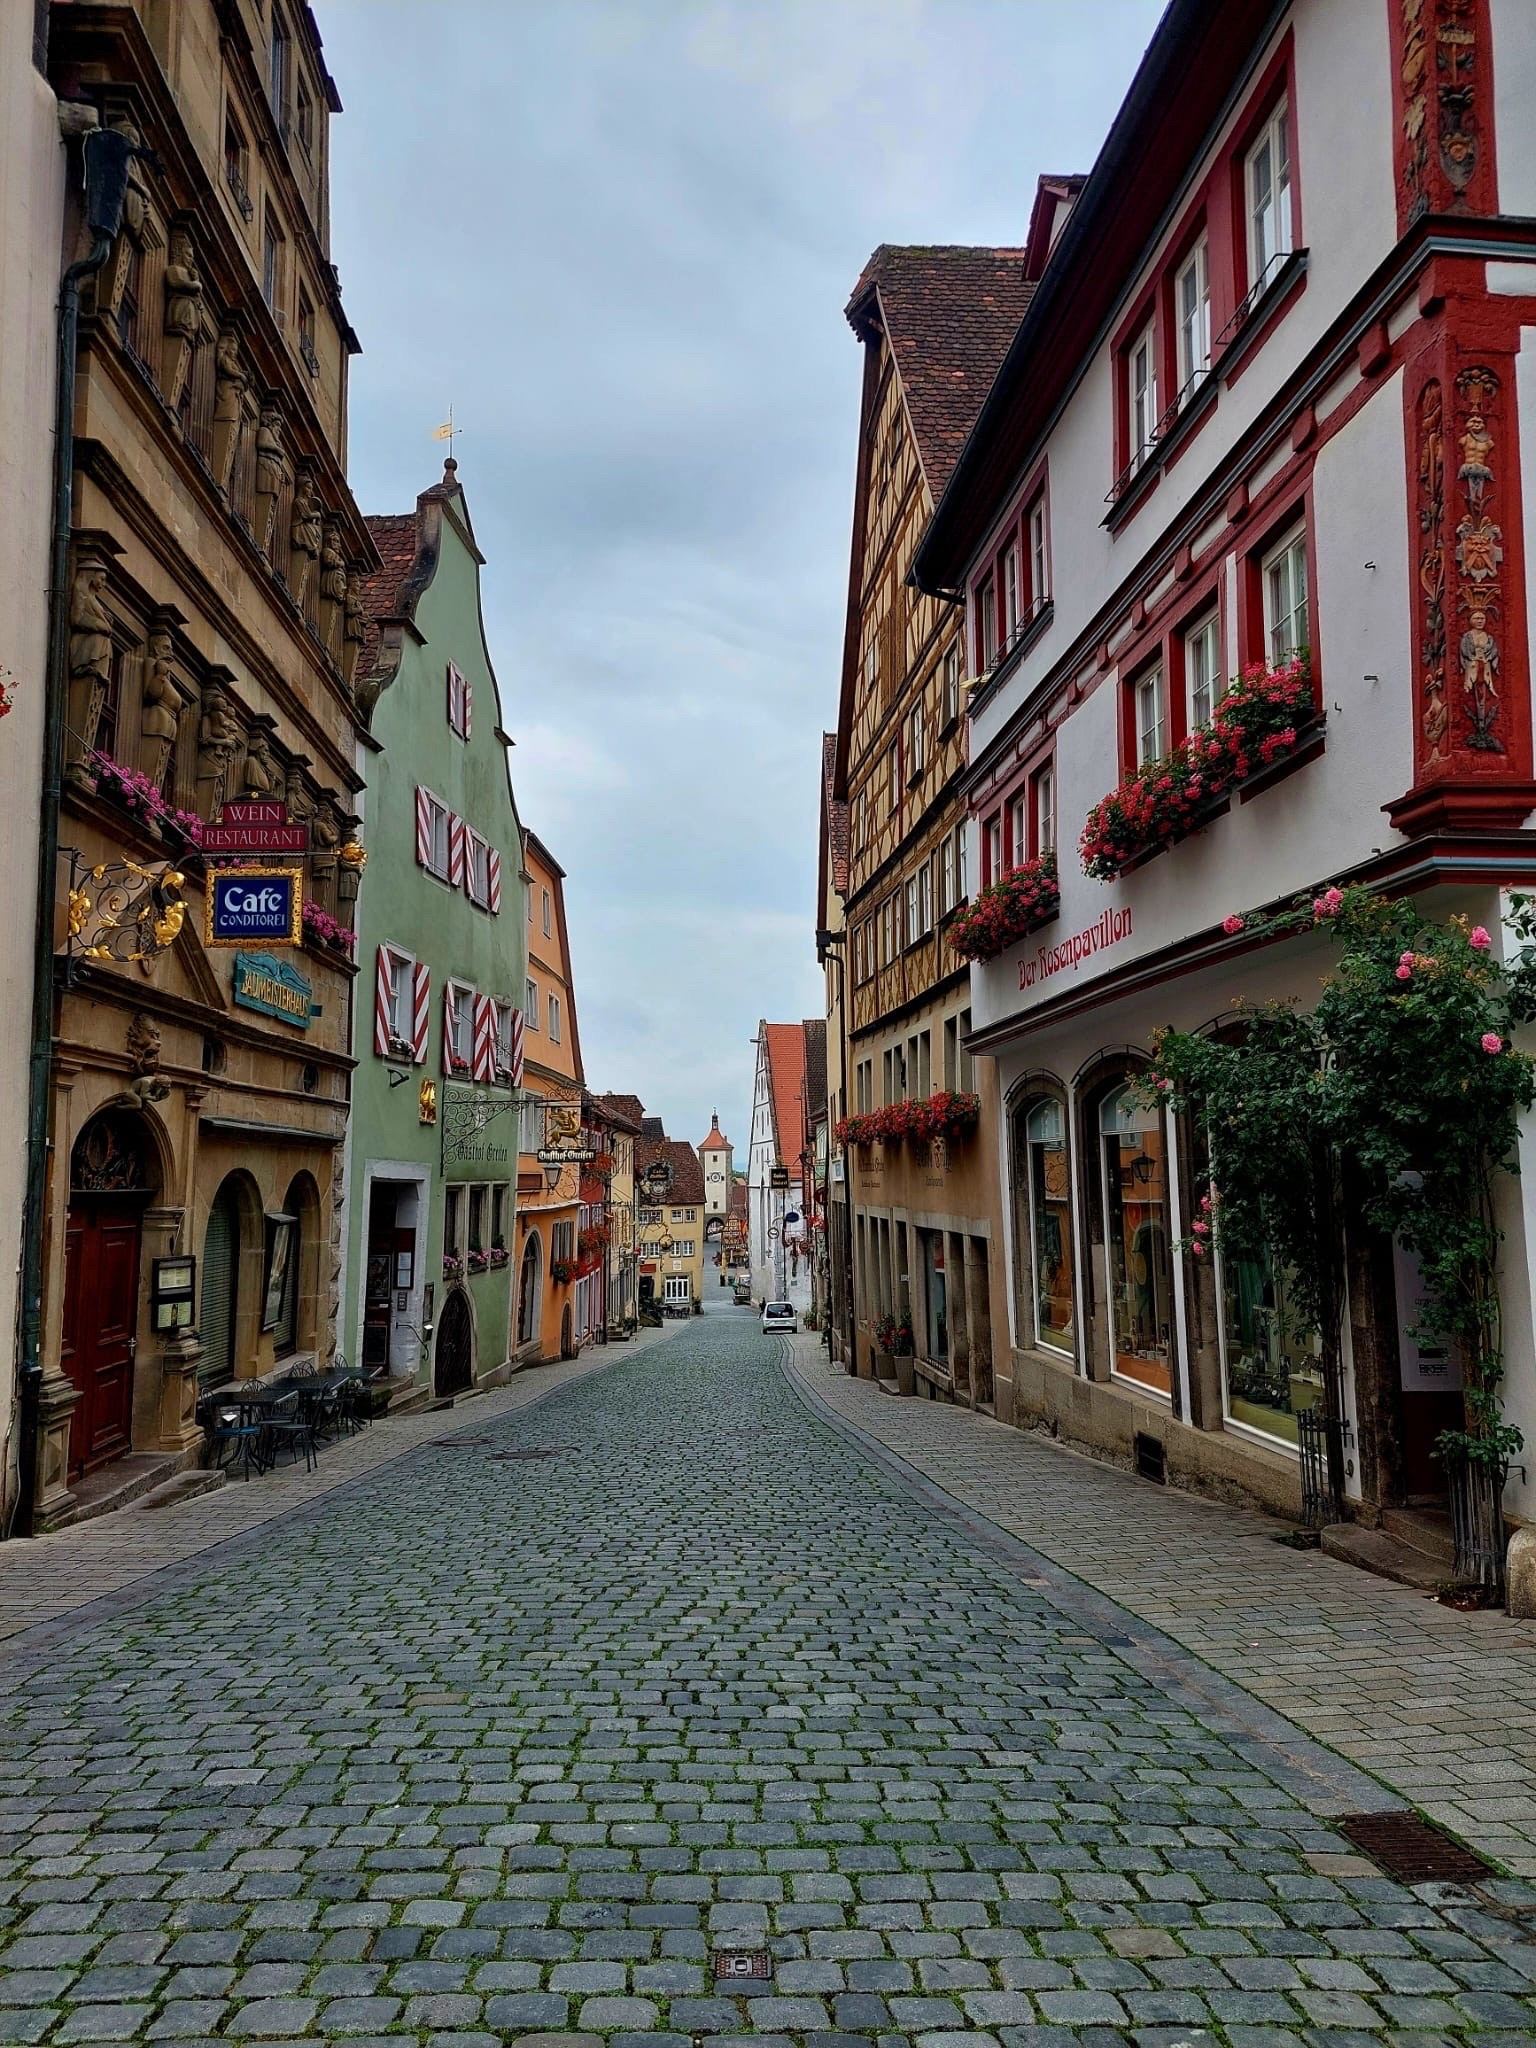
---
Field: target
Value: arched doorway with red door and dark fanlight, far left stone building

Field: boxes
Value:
[59,1110,158,1479]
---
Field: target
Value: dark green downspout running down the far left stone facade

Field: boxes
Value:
[6,129,150,1536]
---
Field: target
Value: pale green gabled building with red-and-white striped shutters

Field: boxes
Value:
[342,459,528,1395]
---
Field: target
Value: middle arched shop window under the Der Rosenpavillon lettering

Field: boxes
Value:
[1098,1087,1174,1395]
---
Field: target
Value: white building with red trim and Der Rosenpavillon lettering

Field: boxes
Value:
[915,0,1536,1520]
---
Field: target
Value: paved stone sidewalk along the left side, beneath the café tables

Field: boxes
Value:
[0,1323,684,1657]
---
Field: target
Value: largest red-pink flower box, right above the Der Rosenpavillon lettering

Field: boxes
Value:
[1079,655,1319,881]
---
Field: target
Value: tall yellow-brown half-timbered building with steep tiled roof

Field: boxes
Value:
[823,246,1028,1409]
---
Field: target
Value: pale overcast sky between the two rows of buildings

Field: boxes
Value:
[317,0,1161,1163]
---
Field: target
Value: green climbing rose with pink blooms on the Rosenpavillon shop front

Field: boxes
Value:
[1147,887,1536,1466]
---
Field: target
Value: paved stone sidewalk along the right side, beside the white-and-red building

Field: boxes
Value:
[795,1337,1536,1876]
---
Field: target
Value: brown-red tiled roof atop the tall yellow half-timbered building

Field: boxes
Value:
[848,242,1034,504]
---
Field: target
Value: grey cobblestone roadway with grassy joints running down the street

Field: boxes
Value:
[0,1311,1536,2048]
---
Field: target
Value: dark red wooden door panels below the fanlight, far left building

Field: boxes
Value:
[61,1202,139,1479]
